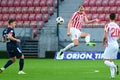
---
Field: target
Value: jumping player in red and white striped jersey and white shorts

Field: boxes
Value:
[58,6,99,56]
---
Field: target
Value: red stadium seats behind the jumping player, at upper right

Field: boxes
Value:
[83,0,120,25]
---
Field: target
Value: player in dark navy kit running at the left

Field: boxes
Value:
[0,19,26,74]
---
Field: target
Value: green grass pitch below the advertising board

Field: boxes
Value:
[0,59,120,80]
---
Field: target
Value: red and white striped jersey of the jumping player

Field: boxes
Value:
[71,11,86,29]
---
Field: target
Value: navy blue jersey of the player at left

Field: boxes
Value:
[2,27,17,44]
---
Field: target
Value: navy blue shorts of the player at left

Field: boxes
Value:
[7,43,22,58]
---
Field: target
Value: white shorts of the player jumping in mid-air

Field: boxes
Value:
[70,27,82,41]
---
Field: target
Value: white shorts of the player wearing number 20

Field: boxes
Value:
[102,43,119,59]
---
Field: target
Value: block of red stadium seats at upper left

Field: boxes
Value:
[0,0,57,28]
